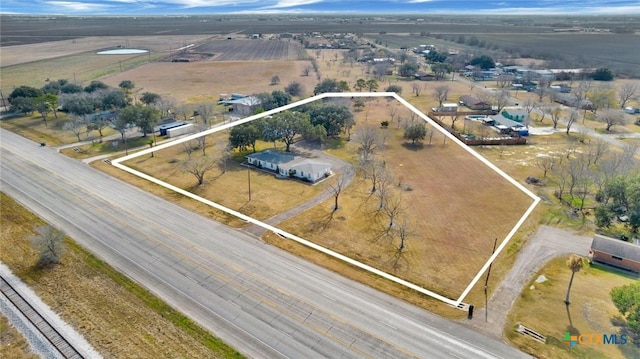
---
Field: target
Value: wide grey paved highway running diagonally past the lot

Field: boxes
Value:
[0,130,527,358]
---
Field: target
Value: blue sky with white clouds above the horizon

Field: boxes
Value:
[0,0,640,16]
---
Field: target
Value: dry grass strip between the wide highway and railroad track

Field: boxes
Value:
[0,193,238,358]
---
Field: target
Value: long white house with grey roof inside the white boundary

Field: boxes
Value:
[247,150,332,183]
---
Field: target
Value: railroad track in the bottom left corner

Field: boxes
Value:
[0,276,84,359]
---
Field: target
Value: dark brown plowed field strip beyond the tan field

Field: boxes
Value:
[194,39,300,61]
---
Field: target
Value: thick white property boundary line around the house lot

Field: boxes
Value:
[111,92,540,307]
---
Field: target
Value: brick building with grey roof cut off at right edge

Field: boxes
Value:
[589,234,640,273]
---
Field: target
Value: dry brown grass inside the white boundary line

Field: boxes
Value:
[117,93,532,304]
